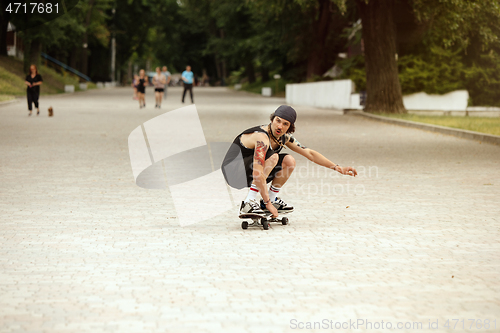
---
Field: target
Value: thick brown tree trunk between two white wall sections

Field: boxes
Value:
[356,0,406,113]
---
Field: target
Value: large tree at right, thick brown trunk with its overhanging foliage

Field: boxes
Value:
[332,0,500,113]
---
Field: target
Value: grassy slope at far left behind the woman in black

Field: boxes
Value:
[0,57,96,96]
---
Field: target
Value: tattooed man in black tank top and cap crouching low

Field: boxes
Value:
[222,105,358,217]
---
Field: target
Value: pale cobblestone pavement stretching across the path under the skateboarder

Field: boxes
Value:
[0,88,500,333]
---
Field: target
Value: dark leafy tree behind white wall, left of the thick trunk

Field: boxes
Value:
[249,0,352,80]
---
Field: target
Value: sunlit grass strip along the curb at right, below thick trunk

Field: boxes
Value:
[380,114,500,135]
